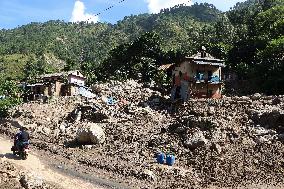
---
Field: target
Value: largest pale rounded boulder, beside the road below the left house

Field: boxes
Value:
[76,123,105,144]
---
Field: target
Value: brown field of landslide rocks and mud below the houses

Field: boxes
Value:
[1,80,284,188]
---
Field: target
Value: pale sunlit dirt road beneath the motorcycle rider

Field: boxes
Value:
[0,137,105,189]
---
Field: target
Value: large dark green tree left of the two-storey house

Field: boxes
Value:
[100,32,162,81]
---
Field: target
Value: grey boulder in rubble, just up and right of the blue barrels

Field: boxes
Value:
[184,131,208,149]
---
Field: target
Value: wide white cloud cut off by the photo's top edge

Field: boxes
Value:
[146,0,192,13]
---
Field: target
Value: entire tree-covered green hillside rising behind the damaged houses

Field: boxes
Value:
[0,0,284,93]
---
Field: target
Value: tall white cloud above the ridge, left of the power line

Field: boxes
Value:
[70,0,99,23]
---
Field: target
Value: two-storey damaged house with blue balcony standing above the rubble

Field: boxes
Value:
[171,47,225,101]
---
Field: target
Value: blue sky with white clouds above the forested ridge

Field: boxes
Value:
[0,0,245,29]
